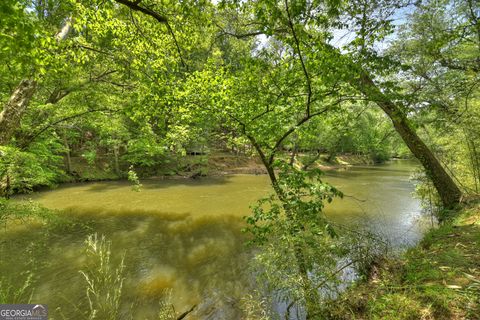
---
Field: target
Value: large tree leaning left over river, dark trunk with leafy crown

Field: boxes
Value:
[219,1,461,208]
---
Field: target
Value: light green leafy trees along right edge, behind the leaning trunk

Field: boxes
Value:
[389,1,480,198]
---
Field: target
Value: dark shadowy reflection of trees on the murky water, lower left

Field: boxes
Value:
[0,210,253,318]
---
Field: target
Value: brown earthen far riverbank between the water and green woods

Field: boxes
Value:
[0,151,402,197]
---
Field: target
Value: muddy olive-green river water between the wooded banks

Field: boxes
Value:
[0,161,425,319]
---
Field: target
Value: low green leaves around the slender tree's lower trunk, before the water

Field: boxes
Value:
[246,161,345,312]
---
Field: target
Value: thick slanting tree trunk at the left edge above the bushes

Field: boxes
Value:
[0,79,37,145]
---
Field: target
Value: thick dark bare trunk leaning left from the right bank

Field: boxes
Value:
[351,72,462,208]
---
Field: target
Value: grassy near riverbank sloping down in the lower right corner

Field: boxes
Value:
[330,202,480,320]
